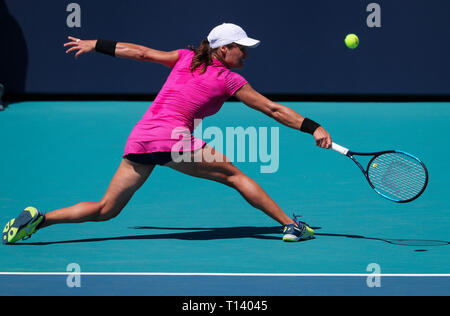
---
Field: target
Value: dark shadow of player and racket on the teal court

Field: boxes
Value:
[10,226,450,251]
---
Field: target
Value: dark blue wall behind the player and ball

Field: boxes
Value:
[0,0,450,95]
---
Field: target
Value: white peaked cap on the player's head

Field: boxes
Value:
[208,23,261,49]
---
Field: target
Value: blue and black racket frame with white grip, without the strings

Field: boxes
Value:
[332,143,428,203]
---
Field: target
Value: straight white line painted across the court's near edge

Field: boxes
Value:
[0,272,450,277]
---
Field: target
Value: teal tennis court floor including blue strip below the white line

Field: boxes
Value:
[0,101,450,296]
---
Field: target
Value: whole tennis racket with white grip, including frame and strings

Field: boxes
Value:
[331,143,428,203]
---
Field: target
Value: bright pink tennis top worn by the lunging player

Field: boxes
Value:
[124,49,247,156]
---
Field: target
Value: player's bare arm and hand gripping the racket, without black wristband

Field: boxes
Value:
[235,84,333,149]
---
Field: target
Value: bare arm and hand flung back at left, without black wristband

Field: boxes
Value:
[64,36,178,67]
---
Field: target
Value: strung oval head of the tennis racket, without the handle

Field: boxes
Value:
[368,153,427,201]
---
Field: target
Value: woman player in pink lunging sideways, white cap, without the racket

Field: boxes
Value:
[2,23,332,244]
